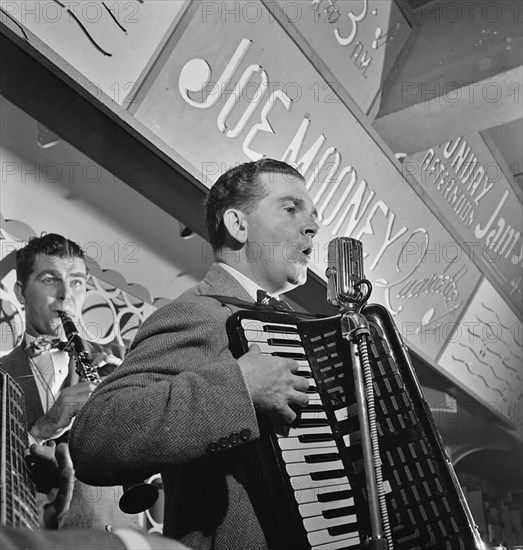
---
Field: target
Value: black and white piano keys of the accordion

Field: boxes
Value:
[242,319,360,550]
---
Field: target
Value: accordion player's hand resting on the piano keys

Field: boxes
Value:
[238,344,309,424]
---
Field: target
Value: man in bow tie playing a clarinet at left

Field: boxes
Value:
[1,233,138,529]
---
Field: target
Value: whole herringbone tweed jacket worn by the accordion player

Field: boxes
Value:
[70,264,266,550]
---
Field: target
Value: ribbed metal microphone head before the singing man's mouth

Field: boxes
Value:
[325,237,371,309]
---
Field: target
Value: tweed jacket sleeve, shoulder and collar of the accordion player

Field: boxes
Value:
[70,265,259,484]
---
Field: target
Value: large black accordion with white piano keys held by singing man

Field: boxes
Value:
[227,304,482,550]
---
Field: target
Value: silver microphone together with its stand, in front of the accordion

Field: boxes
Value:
[327,237,392,550]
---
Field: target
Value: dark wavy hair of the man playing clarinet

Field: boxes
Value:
[16,233,85,289]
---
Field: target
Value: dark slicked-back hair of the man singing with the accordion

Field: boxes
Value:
[204,158,303,250]
